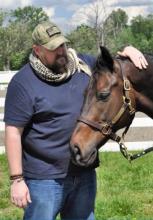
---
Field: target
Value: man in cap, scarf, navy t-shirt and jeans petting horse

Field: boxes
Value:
[4,22,147,220]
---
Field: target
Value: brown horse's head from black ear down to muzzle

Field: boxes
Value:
[70,47,135,166]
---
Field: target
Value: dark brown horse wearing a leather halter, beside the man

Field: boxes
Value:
[70,47,153,167]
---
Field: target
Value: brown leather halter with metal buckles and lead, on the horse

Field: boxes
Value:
[78,59,153,161]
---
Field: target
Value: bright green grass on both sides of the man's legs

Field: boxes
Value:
[0,152,153,220]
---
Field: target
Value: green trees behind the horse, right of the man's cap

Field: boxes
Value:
[68,9,153,54]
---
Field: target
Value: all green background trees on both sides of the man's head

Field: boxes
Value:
[0,6,153,70]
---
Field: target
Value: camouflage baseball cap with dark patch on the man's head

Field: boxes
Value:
[32,21,68,50]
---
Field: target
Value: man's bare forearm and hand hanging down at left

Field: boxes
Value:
[5,125,31,207]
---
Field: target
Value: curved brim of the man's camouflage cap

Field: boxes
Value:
[43,36,69,50]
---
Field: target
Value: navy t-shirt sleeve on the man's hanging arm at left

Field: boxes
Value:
[4,79,34,127]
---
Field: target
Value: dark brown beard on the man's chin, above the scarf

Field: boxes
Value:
[49,55,68,74]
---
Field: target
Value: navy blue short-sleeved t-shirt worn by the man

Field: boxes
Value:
[4,56,98,179]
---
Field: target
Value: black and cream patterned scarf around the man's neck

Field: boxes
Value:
[29,48,92,83]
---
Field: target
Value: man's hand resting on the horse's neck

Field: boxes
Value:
[117,46,148,69]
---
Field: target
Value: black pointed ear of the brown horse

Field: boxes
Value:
[100,46,114,72]
